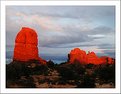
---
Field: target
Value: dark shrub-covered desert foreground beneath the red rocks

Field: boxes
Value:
[6,60,115,88]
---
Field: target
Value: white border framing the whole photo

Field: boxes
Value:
[0,1,120,93]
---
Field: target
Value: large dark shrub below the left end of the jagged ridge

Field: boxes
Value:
[57,62,85,80]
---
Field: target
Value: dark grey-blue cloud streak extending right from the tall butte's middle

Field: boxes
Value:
[40,35,92,47]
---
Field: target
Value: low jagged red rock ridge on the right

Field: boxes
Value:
[68,48,114,65]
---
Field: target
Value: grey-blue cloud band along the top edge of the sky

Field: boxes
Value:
[13,6,115,18]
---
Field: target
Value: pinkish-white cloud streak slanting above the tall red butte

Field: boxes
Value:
[16,12,62,31]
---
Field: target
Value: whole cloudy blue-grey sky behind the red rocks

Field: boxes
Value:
[6,6,115,63]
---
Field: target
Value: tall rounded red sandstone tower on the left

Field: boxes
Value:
[13,27,46,64]
